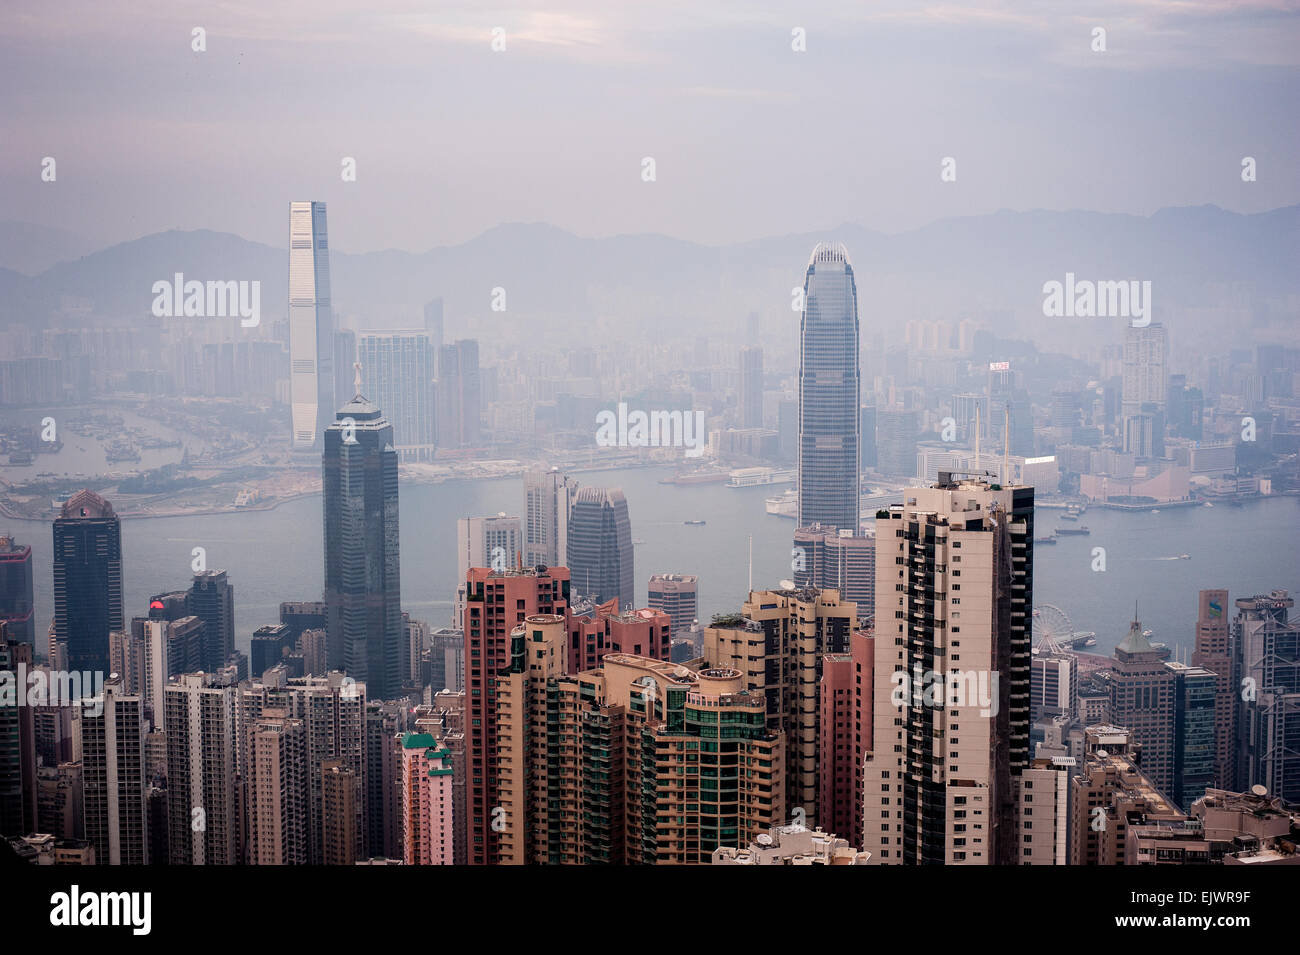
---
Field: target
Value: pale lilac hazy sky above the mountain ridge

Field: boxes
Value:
[0,0,1300,252]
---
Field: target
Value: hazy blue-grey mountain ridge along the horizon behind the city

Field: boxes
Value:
[0,205,1300,347]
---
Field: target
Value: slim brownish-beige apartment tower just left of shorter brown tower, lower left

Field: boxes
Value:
[247,708,311,865]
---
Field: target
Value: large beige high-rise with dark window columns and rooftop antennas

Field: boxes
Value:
[863,472,1034,865]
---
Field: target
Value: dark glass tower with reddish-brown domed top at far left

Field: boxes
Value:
[55,491,125,674]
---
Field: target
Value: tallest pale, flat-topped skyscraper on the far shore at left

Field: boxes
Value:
[289,203,337,451]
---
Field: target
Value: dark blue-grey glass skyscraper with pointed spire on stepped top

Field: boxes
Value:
[321,395,410,699]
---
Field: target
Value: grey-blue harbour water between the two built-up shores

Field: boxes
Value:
[0,468,1300,655]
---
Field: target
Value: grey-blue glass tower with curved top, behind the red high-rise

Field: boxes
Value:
[568,487,636,608]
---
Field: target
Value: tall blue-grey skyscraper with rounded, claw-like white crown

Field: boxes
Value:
[798,243,862,531]
